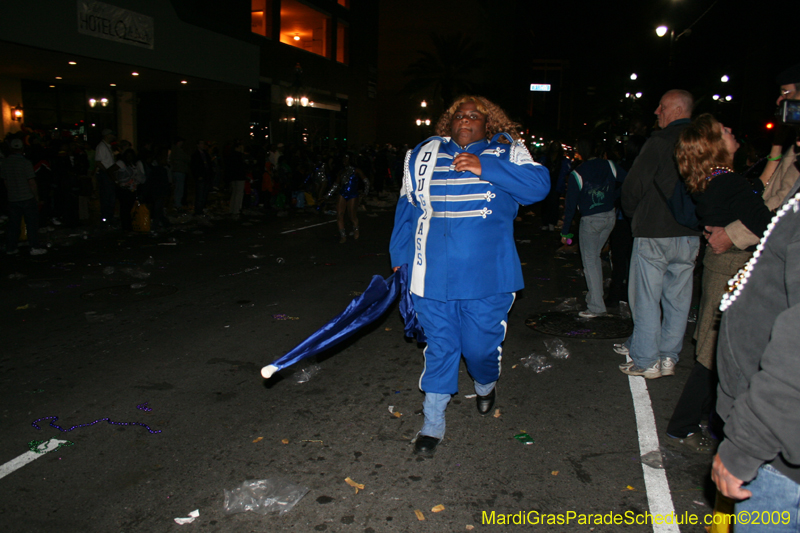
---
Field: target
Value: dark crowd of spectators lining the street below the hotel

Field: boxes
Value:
[0,129,407,245]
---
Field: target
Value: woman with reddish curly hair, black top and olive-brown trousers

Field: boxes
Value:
[667,113,772,451]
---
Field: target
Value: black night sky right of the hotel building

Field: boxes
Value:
[379,0,800,142]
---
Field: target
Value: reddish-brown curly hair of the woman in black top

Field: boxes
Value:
[675,113,733,193]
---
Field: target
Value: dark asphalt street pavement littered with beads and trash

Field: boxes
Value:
[0,197,714,533]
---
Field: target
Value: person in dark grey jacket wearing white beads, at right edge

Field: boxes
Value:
[711,188,800,533]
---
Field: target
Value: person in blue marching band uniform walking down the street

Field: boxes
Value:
[390,96,550,456]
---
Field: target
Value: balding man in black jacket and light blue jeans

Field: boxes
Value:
[615,89,700,379]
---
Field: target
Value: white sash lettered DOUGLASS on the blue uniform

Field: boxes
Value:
[411,140,441,296]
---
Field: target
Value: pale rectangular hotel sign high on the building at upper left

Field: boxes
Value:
[78,0,153,50]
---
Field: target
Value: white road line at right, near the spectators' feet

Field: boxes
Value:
[627,356,680,533]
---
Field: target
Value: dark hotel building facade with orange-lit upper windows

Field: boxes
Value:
[0,0,377,150]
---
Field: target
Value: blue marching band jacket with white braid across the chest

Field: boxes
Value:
[390,133,550,301]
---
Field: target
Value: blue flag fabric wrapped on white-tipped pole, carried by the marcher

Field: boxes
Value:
[261,265,425,378]
